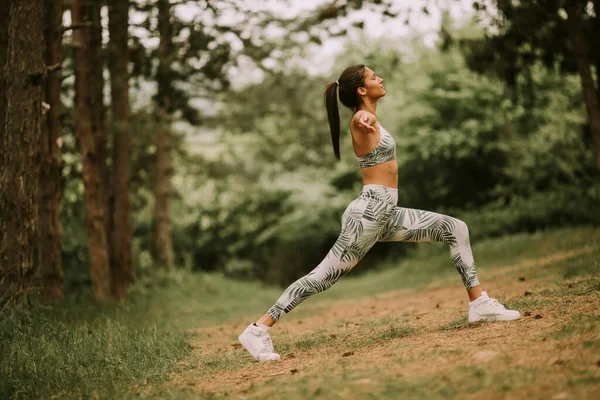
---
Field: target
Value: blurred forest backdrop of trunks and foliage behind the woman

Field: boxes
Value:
[0,0,600,303]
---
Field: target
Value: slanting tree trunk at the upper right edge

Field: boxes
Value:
[565,0,600,169]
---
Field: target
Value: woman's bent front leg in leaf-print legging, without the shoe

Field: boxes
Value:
[380,207,481,290]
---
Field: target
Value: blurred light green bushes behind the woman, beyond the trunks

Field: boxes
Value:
[57,15,600,287]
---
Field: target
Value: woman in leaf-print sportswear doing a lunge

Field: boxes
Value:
[239,65,521,361]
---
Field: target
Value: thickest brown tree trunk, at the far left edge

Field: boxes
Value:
[0,0,46,303]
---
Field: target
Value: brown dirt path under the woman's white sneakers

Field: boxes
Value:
[139,247,600,399]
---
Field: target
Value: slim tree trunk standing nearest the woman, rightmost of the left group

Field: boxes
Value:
[152,0,174,270]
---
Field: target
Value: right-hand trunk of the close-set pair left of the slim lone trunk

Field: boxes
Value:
[108,0,135,301]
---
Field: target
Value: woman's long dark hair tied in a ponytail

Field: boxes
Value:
[323,64,366,160]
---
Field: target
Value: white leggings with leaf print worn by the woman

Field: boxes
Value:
[268,185,479,321]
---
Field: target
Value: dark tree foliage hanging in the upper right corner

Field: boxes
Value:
[459,0,600,91]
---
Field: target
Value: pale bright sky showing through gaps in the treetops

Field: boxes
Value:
[63,0,480,134]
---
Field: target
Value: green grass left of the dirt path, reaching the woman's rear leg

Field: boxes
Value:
[0,271,278,399]
